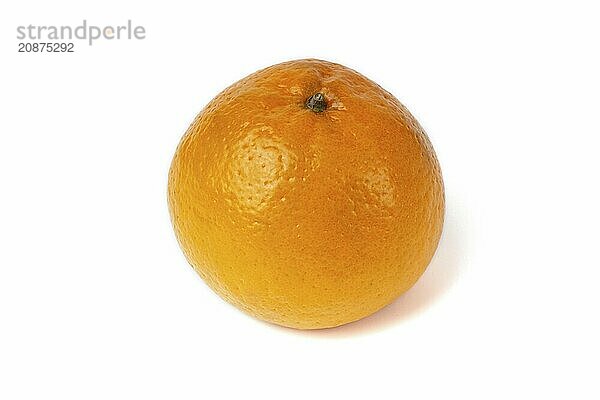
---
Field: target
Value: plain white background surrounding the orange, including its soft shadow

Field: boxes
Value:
[0,0,600,400]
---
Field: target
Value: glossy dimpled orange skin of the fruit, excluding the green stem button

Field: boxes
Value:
[168,59,444,329]
